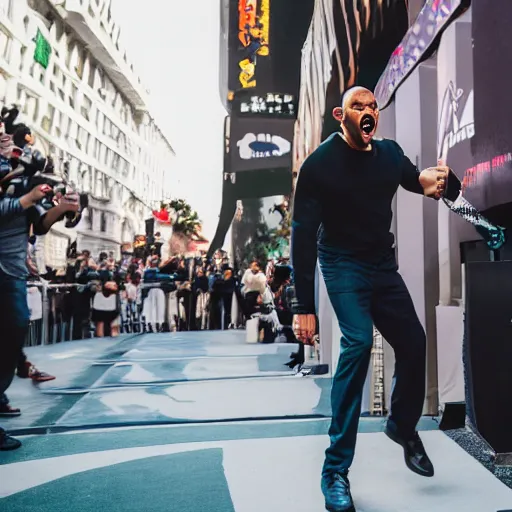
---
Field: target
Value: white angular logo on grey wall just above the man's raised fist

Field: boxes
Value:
[437,81,475,161]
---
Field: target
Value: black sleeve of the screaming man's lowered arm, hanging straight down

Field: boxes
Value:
[291,161,321,315]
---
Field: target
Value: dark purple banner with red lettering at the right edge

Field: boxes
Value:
[465,0,512,227]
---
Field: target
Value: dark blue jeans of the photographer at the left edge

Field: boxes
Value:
[0,270,30,430]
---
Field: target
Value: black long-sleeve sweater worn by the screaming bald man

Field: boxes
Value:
[291,133,423,313]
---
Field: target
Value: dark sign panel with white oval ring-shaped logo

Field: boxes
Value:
[229,118,295,172]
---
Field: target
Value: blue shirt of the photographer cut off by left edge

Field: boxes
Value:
[0,196,46,279]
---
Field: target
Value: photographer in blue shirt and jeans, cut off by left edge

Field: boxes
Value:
[0,185,79,451]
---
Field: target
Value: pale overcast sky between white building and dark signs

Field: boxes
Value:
[112,0,226,240]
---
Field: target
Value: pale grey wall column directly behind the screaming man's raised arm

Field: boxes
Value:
[395,60,439,414]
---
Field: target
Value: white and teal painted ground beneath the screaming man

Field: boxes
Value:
[0,331,512,512]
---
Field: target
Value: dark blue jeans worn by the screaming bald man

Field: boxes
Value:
[318,246,426,474]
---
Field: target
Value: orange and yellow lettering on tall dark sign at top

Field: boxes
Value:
[238,0,270,89]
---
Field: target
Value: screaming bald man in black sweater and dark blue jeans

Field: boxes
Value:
[292,87,450,512]
